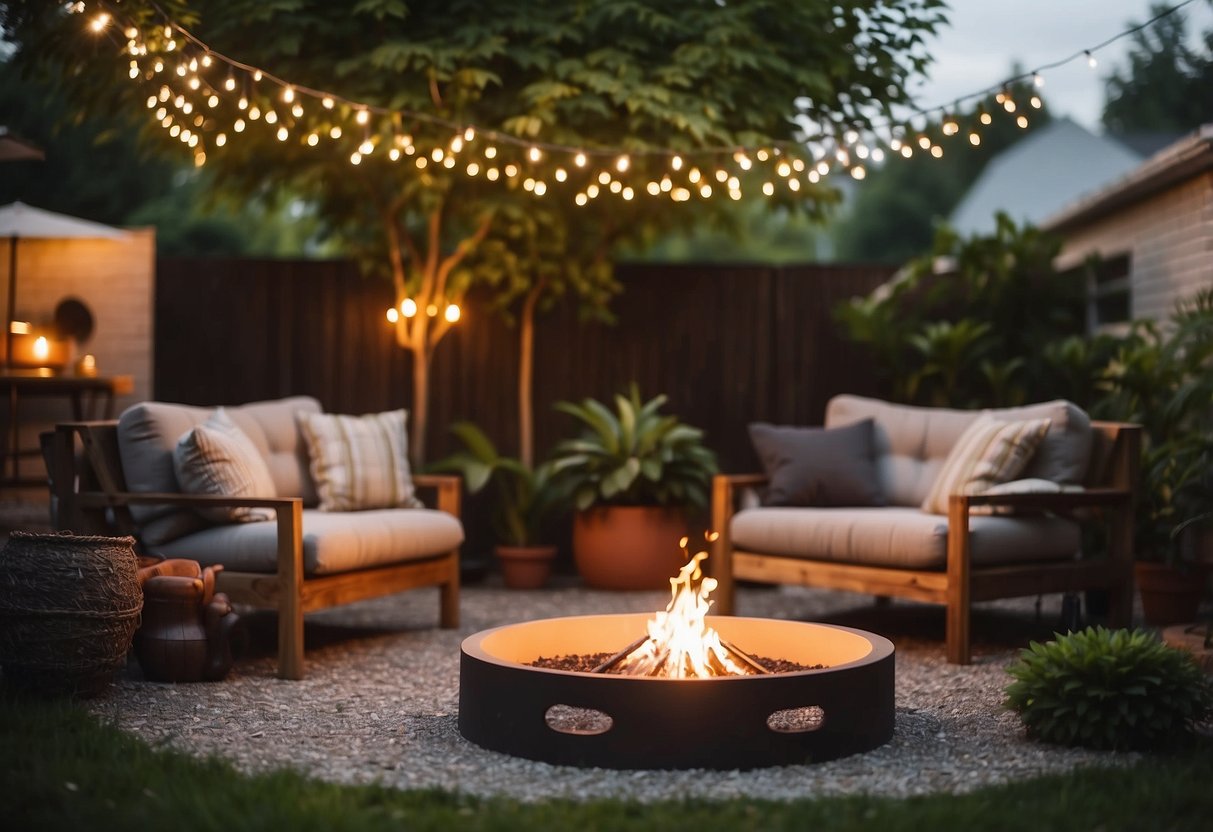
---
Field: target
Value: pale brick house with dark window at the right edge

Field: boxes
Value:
[1040,124,1213,329]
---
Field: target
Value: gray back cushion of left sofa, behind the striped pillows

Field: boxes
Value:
[118,397,320,545]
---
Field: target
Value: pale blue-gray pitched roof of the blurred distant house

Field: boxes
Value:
[950,118,1141,235]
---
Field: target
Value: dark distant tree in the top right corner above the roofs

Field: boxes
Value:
[1103,5,1213,135]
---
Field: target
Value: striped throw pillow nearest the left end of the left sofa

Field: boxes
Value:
[172,408,278,523]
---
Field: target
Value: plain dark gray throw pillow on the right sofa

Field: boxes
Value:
[750,418,887,506]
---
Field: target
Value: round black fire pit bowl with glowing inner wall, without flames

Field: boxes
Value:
[459,614,894,769]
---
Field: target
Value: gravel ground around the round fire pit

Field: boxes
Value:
[89,583,1138,800]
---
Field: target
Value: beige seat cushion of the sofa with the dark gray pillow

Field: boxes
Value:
[730,507,1080,569]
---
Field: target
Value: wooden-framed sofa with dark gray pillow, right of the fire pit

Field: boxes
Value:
[710,395,1140,663]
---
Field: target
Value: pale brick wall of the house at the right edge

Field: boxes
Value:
[1058,171,1213,319]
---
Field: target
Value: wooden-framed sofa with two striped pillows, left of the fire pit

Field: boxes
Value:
[50,397,463,679]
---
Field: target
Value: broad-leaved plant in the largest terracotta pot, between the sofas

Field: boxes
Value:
[552,384,717,589]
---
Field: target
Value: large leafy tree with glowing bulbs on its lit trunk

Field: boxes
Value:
[4,0,944,458]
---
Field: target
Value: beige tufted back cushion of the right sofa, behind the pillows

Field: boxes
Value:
[826,394,1092,506]
